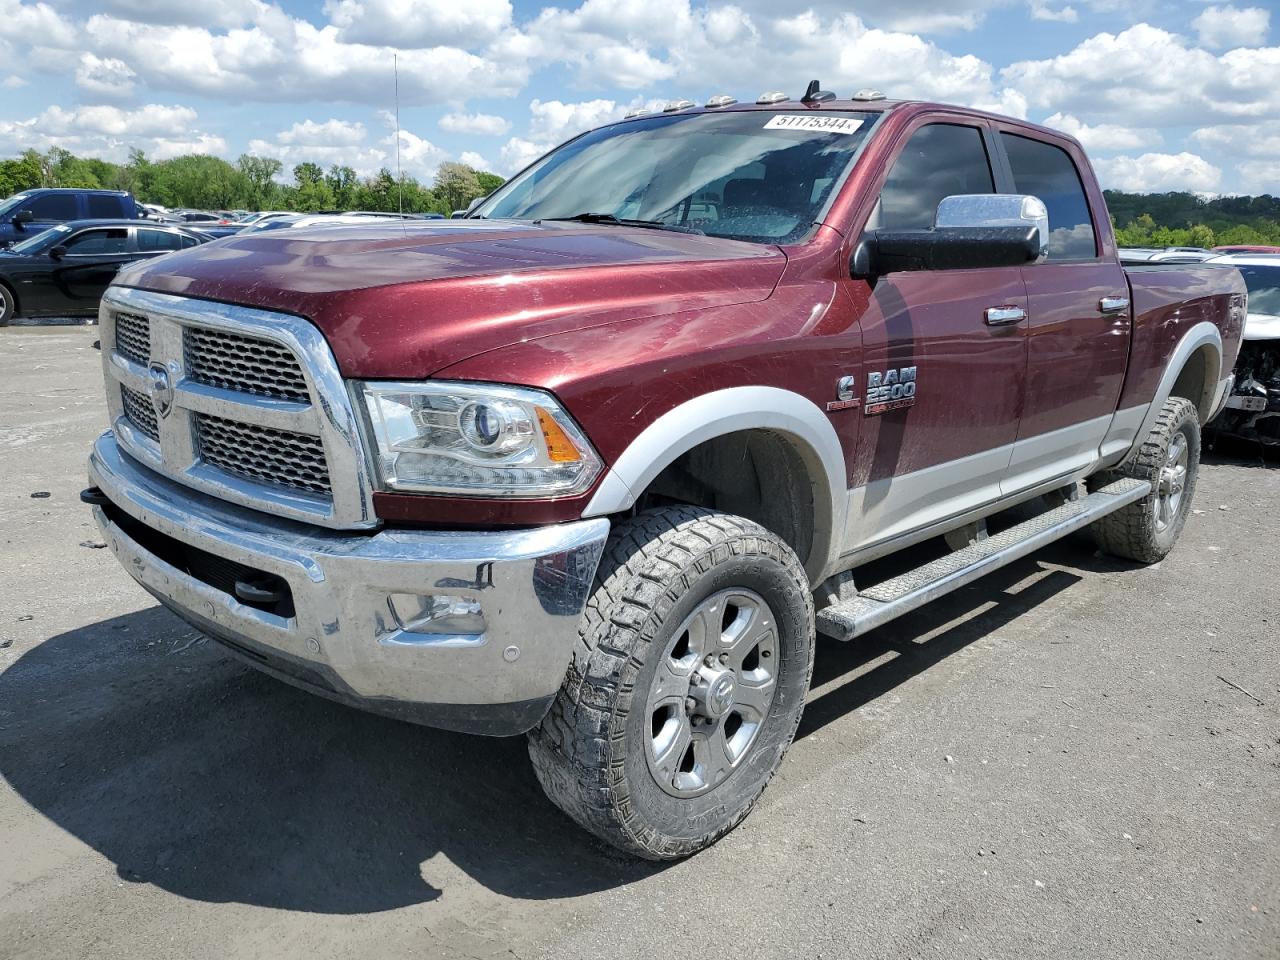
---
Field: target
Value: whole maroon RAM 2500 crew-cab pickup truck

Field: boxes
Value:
[84,90,1245,859]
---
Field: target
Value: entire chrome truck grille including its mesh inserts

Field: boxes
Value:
[101,287,379,530]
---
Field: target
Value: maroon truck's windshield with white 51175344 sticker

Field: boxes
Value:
[472,108,878,243]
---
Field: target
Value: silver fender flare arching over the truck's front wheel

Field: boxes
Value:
[582,387,849,584]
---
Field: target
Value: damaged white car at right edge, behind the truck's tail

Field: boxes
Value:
[1206,253,1280,447]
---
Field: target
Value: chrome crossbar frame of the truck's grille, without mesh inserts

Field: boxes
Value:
[99,287,379,529]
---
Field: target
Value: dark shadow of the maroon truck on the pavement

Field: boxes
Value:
[0,543,1114,914]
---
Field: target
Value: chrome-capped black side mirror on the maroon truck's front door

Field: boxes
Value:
[849,193,1048,282]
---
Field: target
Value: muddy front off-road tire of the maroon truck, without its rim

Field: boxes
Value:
[529,507,814,860]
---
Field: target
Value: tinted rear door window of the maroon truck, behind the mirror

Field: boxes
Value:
[1000,133,1098,260]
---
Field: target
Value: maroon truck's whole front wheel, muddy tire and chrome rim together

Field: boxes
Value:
[529,507,814,860]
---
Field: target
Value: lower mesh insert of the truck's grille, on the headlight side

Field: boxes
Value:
[195,413,330,495]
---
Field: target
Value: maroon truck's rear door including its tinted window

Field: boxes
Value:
[1000,129,1130,494]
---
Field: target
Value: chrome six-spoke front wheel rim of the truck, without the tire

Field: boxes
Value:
[645,589,778,797]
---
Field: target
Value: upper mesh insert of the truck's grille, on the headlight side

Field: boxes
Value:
[183,326,311,403]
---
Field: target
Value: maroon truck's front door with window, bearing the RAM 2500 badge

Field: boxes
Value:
[846,119,1028,552]
